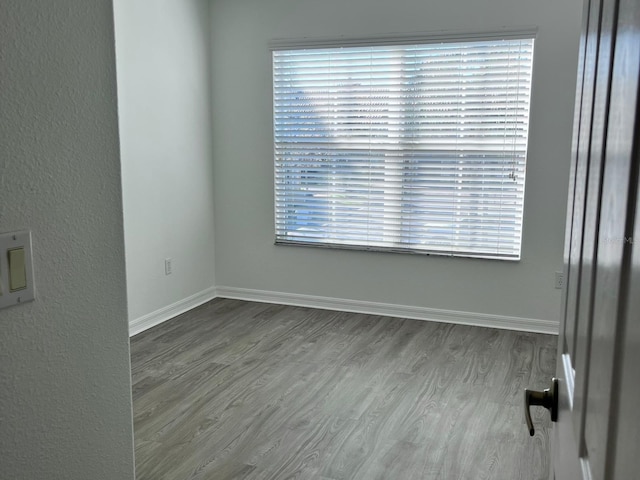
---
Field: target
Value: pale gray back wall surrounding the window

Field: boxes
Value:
[211,0,582,326]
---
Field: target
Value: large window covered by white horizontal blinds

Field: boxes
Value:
[272,33,534,260]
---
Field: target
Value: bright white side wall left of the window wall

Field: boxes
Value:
[114,0,214,330]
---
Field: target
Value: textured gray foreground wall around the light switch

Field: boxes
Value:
[0,0,134,480]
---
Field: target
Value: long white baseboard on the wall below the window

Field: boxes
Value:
[216,286,559,335]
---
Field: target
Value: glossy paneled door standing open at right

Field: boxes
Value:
[525,0,640,480]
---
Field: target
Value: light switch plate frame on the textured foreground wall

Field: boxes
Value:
[0,230,36,308]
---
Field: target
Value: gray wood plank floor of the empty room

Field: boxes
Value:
[131,299,557,480]
